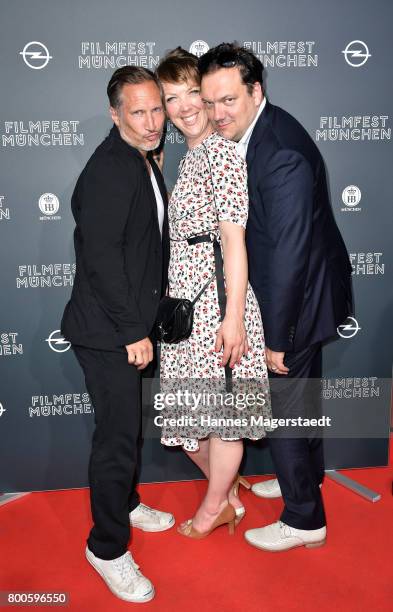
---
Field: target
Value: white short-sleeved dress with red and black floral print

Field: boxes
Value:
[160,132,269,450]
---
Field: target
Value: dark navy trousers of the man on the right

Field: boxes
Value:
[269,343,326,529]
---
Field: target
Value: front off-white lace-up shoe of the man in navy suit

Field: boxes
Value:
[244,521,326,552]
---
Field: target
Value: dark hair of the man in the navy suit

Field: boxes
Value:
[198,43,264,94]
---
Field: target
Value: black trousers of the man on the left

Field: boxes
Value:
[72,345,141,559]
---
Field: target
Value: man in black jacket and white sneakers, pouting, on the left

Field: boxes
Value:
[62,66,174,602]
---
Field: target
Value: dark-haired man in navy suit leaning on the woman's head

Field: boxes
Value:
[199,43,352,551]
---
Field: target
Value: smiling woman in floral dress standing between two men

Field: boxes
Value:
[157,47,268,537]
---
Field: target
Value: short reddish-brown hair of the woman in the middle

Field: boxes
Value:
[156,47,201,85]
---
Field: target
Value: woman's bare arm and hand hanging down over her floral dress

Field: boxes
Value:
[215,221,248,368]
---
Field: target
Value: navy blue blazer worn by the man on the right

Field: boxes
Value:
[246,101,352,352]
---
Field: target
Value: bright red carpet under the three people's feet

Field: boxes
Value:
[0,456,393,612]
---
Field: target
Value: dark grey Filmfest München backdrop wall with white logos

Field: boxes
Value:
[0,0,393,491]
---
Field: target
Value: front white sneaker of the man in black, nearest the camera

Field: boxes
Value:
[86,547,154,603]
